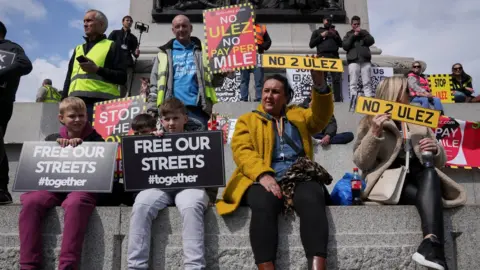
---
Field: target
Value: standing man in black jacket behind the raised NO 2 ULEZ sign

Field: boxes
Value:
[310,18,343,102]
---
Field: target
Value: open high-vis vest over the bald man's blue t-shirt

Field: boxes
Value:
[157,44,218,107]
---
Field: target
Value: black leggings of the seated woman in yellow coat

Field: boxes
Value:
[246,182,328,264]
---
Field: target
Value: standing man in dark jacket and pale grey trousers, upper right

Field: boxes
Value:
[343,16,375,109]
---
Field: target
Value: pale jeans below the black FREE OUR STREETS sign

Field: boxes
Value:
[127,188,209,270]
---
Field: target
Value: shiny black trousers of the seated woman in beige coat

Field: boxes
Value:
[400,166,444,240]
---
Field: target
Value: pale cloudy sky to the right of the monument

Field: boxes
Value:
[368,0,480,93]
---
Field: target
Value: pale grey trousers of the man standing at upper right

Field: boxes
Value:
[348,62,375,97]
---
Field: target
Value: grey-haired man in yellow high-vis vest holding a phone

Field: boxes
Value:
[62,9,127,121]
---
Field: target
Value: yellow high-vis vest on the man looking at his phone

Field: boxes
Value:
[68,39,120,99]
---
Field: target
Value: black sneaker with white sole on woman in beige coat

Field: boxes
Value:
[412,236,448,270]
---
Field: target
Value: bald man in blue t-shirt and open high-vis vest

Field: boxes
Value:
[147,15,226,131]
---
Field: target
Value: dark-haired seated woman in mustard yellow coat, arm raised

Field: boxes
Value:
[216,71,333,269]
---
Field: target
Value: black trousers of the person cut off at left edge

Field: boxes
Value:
[0,102,13,190]
